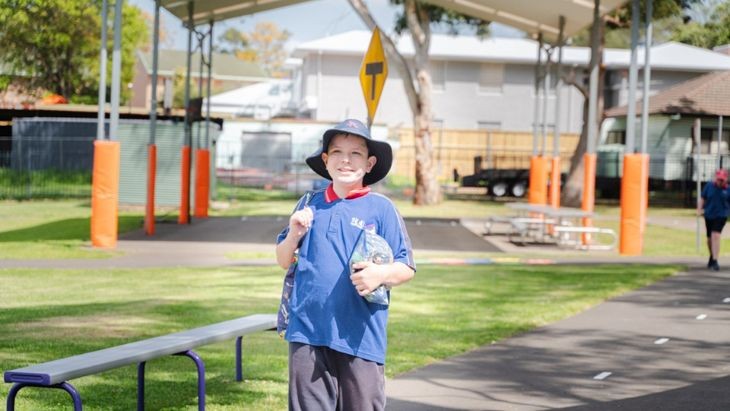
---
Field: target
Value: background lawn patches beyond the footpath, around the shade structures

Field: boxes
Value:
[0,186,716,259]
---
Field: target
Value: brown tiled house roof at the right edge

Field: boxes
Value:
[606,71,730,117]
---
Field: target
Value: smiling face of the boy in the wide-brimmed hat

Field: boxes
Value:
[322,134,377,188]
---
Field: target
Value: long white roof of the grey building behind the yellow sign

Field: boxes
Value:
[293,30,730,72]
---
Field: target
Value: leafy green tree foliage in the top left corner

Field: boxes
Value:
[0,0,149,101]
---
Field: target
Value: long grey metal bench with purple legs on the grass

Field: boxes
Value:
[4,314,276,411]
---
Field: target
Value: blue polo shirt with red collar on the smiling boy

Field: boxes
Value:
[277,186,416,364]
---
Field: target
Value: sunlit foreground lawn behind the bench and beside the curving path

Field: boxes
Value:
[0,265,680,410]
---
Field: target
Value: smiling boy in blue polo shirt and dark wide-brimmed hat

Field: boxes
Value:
[276,120,415,411]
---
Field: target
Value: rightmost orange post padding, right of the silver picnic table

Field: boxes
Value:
[619,154,649,255]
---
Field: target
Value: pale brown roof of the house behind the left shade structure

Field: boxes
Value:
[137,50,267,81]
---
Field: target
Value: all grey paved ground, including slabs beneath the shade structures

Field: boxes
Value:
[0,214,730,411]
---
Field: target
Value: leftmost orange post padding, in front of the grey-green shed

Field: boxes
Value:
[91,140,120,248]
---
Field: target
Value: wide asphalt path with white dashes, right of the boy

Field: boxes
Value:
[386,269,730,411]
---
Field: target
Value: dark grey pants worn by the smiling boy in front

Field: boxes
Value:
[289,343,385,411]
